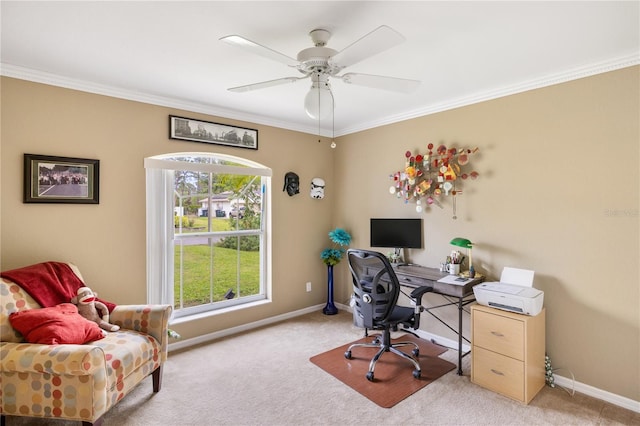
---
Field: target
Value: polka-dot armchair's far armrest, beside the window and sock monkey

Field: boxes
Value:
[109,305,171,349]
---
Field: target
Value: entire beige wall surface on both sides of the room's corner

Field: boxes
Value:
[0,67,640,400]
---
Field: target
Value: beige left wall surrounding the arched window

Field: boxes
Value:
[1,78,336,339]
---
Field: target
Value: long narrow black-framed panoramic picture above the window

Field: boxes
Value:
[169,115,258,149]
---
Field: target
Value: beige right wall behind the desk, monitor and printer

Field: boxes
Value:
[335,67,640,401]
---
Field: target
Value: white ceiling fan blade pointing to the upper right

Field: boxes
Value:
[329,25,405,69]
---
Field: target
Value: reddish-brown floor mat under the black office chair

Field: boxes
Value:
[310,334,456,408]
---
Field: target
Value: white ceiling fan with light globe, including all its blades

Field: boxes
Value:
[220,25,420,119]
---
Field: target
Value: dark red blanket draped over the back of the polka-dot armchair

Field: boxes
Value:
[0,262,116,312]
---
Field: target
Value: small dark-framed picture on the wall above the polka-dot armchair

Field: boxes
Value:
[23,154,100,204]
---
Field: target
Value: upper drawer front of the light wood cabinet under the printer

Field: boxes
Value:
[472,310,525,361]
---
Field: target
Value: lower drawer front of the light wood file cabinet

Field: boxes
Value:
[471,346,524,401]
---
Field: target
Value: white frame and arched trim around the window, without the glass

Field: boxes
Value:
[144,152,272,318]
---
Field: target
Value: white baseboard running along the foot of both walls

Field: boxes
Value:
[168,303,640,413]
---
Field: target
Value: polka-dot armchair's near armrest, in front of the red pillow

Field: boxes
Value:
[0,342,107,376]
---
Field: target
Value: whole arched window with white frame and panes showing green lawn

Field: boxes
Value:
[144,152,271,318]
